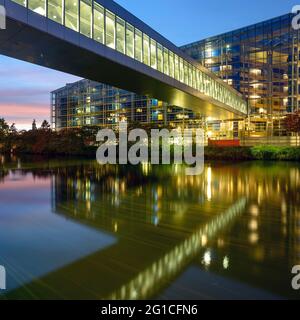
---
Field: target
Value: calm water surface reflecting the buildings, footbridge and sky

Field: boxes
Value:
[0,157,300,299]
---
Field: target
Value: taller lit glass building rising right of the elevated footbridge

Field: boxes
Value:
[181,14,300,135]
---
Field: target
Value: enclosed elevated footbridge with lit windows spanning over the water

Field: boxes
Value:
[0,0,247,118]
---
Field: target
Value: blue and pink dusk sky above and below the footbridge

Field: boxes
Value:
[0,0,300,129]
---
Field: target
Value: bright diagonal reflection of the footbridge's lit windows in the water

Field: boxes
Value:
[108,198,246,300]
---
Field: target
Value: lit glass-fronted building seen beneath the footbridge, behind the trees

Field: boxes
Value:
[51,80,202,129]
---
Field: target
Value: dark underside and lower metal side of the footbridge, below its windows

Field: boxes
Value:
[0,13,245,119]
